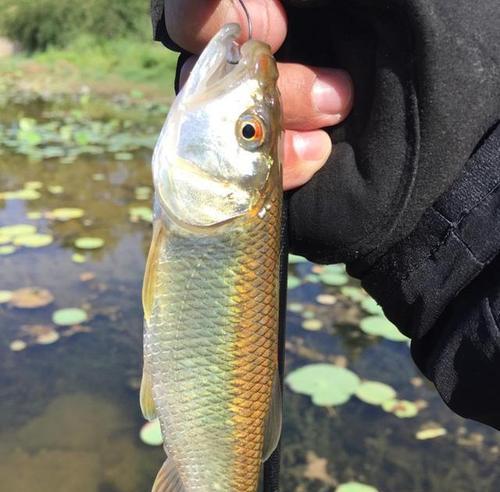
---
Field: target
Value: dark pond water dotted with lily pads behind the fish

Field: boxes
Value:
[0,94,500,492]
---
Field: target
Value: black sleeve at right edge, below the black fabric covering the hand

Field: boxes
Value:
[354,125,500,429]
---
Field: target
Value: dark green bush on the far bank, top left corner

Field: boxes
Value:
[0,0,150,51]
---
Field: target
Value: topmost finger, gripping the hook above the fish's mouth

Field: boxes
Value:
[165,0,286,53]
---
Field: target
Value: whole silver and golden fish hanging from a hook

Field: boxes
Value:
[140,24,283,492]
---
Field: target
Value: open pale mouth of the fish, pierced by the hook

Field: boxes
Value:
[179,23,278,101]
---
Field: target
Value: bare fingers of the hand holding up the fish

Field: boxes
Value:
[165,0,353,189]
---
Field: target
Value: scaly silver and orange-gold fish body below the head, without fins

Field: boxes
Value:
[144,198,280,492]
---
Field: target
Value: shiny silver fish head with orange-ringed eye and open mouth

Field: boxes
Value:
[153,24,281,227]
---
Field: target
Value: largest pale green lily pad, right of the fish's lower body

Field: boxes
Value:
[285,364,360,406]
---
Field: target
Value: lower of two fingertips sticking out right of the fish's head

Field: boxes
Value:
[283,130,332,190]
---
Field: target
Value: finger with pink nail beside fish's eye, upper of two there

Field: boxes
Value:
[278,63,353,130]
